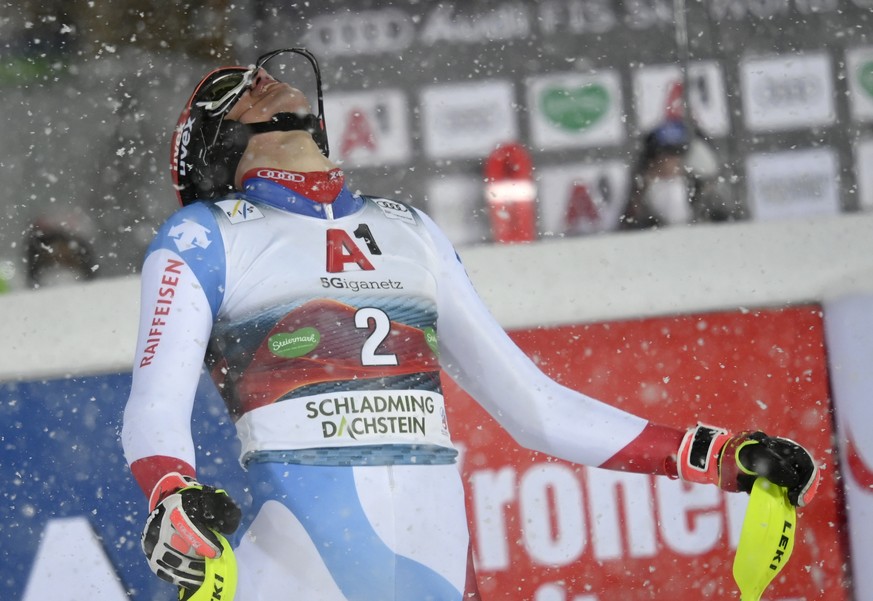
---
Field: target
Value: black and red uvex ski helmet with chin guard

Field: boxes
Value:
[170,48,330,205]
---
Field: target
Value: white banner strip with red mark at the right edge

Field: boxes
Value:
[824,292,873,599]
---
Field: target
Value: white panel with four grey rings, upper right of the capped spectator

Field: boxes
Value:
[740,52,836,131]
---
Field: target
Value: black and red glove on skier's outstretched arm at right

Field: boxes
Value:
[677,424,821,507]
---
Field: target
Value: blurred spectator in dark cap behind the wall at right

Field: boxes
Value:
[619,120,731,230]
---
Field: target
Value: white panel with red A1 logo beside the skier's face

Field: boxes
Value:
[324,90,411,167]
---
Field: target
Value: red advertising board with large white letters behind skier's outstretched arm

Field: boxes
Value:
[446,306,851,601]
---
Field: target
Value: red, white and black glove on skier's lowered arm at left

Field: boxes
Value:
[142,472,241,589]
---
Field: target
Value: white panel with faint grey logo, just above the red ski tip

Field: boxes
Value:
[421,80,518,159]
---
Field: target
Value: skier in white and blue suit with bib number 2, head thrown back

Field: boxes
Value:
[122,48,819,601]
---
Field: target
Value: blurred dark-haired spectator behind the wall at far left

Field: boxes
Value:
[24,220,97,288]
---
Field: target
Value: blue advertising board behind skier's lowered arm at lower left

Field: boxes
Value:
[0,373,247,601]
